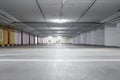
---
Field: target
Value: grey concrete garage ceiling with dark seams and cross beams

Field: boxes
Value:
[0,0,120,37]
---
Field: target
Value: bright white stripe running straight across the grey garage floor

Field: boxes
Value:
[0,59,120,62]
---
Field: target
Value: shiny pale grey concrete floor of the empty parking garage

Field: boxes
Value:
[0,45,120,80]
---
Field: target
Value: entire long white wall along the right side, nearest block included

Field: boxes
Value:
[70,23,120,47]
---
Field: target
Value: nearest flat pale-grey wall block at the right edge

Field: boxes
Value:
[105,24,117,46]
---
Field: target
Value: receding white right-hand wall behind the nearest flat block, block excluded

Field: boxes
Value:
[71,28,104,45]
